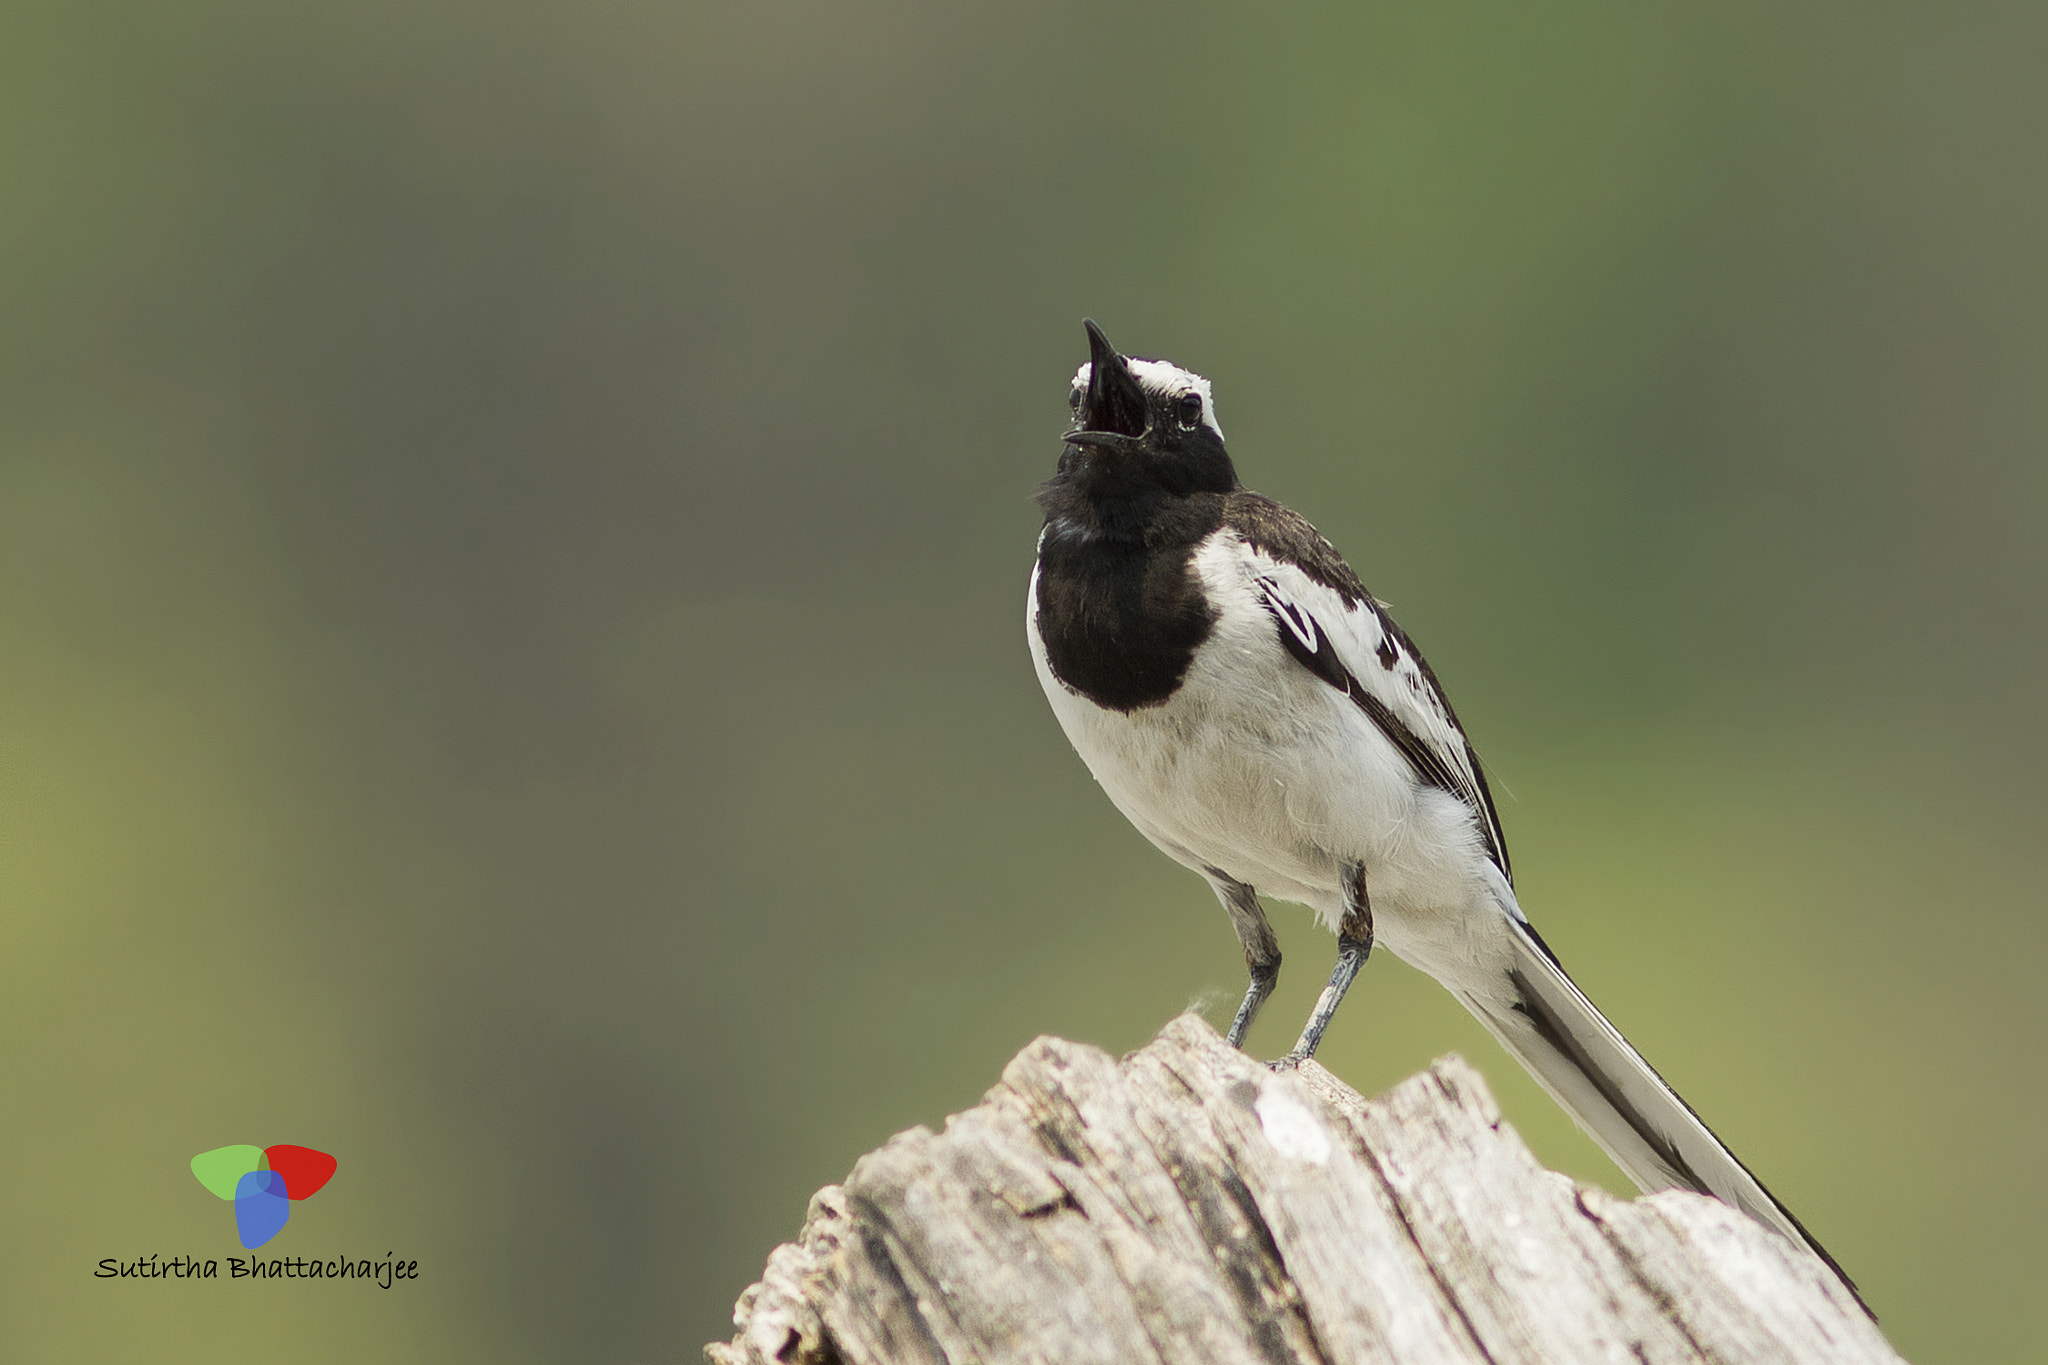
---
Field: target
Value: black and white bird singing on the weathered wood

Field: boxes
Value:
[1026,321,1853,1289]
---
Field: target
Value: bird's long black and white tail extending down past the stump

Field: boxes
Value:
[1452,917,1876,1316]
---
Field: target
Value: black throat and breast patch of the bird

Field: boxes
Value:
[1034,460,1235,712]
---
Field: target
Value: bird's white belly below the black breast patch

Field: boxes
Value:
[1026,556,1491,960]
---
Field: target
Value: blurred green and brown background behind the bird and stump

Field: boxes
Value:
[0,0,2048,1363]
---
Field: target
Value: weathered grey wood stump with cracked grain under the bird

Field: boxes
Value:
[707,1015,1898,1365]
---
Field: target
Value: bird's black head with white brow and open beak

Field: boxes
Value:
[1059,321,1237,495]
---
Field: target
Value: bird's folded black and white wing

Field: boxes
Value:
[1229,493,1513,884]
